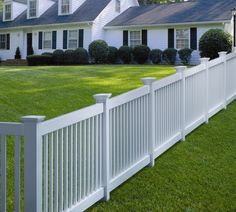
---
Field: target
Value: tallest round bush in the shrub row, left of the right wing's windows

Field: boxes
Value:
[89,40,109,63]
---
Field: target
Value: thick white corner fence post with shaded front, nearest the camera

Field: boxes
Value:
[21,116,45,212]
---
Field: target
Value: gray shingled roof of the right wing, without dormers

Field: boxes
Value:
[106,0,236,27]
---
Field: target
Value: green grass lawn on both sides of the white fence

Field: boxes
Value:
[0,65,236,211]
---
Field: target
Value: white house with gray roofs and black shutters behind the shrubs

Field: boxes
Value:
[0,0,236,63]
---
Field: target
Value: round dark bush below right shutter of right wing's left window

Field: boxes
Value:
[133,45,150,64]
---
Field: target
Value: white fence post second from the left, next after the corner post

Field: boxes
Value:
[93,94,111,201]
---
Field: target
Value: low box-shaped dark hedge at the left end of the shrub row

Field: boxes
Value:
[27,55,52,66]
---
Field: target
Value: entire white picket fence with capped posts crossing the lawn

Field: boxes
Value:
[0,52,236,212]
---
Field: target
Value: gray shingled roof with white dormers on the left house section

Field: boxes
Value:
[0,0,110,28]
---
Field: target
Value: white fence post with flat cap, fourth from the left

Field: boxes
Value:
[175,66,187,141]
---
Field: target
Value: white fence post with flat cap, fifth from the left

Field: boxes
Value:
[200,57,210,124]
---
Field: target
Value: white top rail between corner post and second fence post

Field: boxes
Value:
[40,104,103,135]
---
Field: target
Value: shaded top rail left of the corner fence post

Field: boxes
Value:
[0,122,24,136]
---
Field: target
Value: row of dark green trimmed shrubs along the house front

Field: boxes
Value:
[27,40,193,66]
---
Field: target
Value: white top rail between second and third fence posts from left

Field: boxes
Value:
[108,86,149,109]
